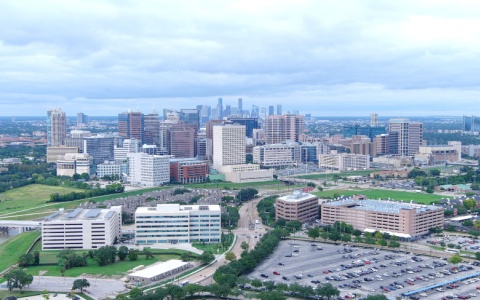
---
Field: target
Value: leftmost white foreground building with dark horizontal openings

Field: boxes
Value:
[42,206,122,250]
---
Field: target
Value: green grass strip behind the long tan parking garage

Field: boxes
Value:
[313,189,445,204]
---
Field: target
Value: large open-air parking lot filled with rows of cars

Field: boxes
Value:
[249,241,480,299]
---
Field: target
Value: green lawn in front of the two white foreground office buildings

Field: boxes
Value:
[26,252,179,277]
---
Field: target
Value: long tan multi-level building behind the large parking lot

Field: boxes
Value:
[321,195,444,239]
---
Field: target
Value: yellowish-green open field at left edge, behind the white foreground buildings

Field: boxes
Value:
[0,184,82,216]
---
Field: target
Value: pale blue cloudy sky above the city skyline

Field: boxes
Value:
[0,0,480,116]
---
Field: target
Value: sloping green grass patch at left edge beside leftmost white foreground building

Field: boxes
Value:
[0,231,40,271]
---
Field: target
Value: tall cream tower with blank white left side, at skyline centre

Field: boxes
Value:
[213,124,246,167]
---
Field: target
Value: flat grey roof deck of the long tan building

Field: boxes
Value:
[322,198,443,214]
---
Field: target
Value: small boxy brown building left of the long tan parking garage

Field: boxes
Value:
[275,191,319,222]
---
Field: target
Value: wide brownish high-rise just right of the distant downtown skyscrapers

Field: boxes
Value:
[265,114,304,144]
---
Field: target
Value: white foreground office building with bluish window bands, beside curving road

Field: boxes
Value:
[135,204,221,245]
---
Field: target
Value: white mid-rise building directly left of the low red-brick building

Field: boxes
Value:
[127,153,170,186]
